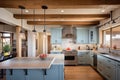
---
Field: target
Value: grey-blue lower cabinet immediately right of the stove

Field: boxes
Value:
[78,52,89,64]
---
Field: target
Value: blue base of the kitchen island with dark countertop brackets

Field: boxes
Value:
[6,64,64,80]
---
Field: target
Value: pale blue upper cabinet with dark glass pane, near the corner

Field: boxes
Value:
[89,28,98,43]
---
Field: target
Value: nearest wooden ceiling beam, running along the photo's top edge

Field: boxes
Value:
[0,0,120,9]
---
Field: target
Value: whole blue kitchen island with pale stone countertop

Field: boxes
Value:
[0,54,64,80]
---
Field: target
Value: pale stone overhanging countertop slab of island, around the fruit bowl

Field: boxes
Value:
[0,57,55,69]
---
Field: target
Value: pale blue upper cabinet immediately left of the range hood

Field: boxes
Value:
[51,28,62,44]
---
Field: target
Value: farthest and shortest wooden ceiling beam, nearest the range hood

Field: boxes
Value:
[27,21,99,26]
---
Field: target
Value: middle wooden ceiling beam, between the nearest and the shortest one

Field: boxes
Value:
[14,14,110,19]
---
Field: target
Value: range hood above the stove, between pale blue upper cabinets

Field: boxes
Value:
[62,26,75,38]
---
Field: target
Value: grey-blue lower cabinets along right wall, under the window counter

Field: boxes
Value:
[97,55,116,80]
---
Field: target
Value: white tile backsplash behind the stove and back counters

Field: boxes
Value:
[52,39,94,50]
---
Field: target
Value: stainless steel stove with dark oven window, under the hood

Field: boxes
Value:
[63,50,77,65]
